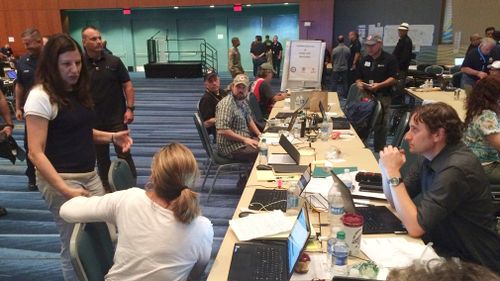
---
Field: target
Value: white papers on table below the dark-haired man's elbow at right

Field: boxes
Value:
[361,236,439,268]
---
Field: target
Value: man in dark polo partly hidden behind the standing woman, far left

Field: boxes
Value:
[14,28,43,191]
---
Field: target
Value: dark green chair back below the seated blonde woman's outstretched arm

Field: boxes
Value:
[69,222,115,281]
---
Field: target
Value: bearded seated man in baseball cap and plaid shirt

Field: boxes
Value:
[215,74,261,162]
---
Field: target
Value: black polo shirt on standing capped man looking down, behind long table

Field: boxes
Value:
[356,51,398,95]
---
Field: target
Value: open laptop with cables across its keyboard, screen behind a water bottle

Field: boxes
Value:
[248,165,311,212]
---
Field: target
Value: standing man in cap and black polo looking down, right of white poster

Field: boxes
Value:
[356,35,398,151]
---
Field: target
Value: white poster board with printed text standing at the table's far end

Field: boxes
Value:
[281,40,326,91]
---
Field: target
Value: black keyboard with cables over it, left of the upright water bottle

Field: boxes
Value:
[248,189,287,212]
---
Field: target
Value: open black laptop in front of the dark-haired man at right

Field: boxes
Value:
[332,173,407,234]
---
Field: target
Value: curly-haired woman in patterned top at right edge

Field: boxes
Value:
[463,76,500,184]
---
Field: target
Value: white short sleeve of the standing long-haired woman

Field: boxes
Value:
[24,84,58,120]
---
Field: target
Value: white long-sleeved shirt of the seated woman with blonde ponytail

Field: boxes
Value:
[60,188,214,281]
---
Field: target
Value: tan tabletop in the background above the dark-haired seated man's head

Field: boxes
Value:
[406,88,467,121]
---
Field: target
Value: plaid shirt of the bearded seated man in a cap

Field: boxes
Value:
[215,94,252,155]
